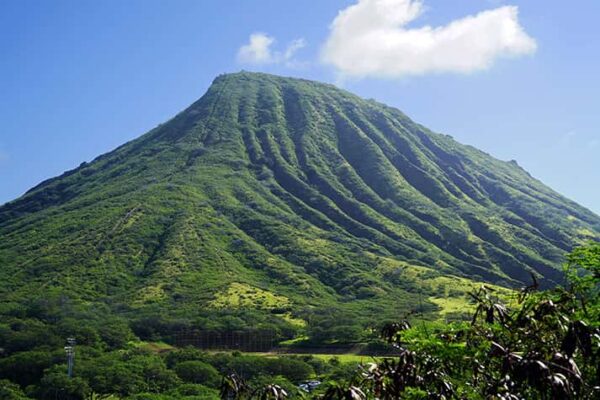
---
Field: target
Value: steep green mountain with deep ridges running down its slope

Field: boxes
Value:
[0,72,600,329]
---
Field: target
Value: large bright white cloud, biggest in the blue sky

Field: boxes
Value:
[321,0,537,78]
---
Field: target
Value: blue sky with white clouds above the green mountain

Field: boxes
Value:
[0,0,600,213]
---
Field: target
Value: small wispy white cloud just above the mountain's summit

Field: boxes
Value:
[237,33,306,66]
